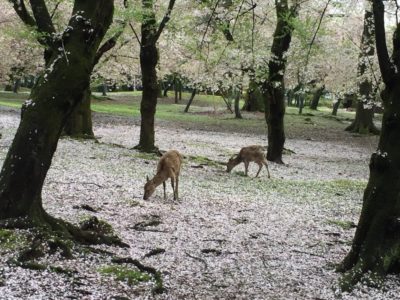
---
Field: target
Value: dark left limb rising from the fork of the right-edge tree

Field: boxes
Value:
[372,0,395,86]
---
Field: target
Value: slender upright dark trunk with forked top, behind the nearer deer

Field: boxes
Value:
[135,0,175,152]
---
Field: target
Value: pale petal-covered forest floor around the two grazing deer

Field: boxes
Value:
[0,98,400,299]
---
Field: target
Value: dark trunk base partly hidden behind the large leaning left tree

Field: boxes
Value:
[63,88,94,139]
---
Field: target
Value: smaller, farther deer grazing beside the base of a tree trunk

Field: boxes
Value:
[226,145,271,178]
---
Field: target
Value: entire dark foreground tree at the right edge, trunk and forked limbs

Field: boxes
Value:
[339,0,400,290]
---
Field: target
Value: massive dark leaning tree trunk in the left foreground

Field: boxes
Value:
[0,0,113,237]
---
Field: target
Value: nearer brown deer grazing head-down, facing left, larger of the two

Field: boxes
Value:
[143,150,182,200]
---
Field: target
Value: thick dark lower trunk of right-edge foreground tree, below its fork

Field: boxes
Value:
[339,84,400,289]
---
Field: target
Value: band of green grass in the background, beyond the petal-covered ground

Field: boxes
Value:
[0,91,360,137]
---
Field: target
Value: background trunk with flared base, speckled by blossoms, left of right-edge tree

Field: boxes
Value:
[345,9,379,134]
